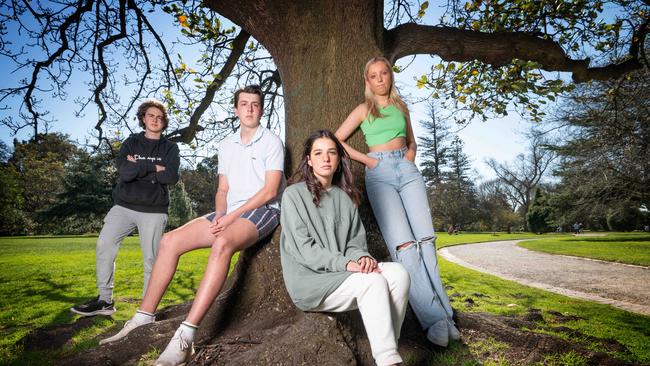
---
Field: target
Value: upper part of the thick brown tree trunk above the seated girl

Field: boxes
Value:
[213,0,384,168]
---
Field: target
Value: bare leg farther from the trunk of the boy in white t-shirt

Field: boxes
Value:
[140,217,216,313]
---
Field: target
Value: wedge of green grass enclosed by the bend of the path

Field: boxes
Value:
[519,233,650,266]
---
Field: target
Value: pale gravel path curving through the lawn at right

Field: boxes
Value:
[439,240,650,315]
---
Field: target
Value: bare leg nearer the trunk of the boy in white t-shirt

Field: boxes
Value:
[184,218,258,325]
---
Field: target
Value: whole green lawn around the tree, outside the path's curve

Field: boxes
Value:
[0,233,650,365]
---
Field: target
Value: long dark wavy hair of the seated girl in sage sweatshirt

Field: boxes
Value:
[292,130,361,206]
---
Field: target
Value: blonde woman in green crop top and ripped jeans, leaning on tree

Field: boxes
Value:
[336,57,460,347]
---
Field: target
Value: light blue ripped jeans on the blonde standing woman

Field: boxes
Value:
[366,149,453,329]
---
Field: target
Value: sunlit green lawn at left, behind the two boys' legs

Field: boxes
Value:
[0,236,232,364]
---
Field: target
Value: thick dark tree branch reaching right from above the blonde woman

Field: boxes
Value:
[385,21,648,82]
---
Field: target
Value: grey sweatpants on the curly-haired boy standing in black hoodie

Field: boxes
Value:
[95,205,167,301]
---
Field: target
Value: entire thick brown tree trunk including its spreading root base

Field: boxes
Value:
[64,0,431,365]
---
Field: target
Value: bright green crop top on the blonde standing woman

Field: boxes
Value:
[361,104,406,146]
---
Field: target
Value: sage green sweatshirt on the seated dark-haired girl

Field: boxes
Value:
[280,182,370,311]
